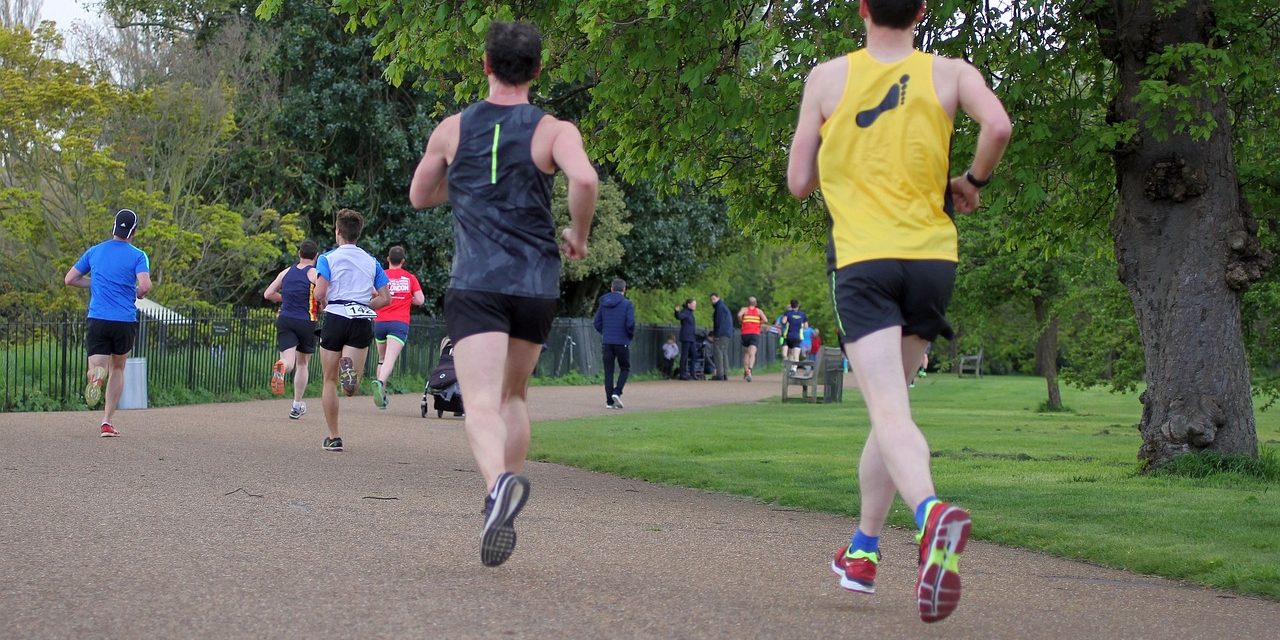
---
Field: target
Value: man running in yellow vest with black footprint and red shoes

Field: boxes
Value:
[787,0,1011,622]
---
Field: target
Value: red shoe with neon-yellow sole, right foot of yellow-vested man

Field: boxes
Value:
[915,502,973,622]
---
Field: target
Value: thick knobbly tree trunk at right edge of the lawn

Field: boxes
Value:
[1093,0,1270,466]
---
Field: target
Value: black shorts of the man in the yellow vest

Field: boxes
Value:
[831,260,956,343]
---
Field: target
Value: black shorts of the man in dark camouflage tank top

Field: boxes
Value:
[444,289,556,344]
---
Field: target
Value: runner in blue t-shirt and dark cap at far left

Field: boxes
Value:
[63,209,151,438]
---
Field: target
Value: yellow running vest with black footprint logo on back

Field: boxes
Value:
[818,49,957,269]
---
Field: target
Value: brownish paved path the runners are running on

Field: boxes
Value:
[0,376,1280,639]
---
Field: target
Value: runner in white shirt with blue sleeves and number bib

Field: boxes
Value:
[315,209,392,451]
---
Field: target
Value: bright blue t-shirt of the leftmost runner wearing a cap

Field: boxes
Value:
[76,239,151,323]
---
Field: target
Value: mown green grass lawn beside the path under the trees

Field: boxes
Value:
[531,375,1280,599]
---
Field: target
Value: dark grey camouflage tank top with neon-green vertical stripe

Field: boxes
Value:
[448,101,561,298]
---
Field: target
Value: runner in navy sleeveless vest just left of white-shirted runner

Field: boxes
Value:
[262,241,320,420]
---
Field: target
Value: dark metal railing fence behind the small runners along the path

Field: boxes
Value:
[0,310,778,412]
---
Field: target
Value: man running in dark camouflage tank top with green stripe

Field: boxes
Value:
[410,22,598,567]
